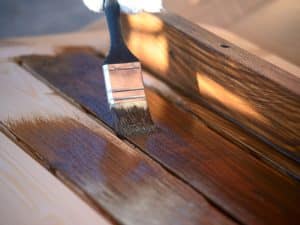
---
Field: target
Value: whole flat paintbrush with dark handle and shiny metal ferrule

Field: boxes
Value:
[102,0,154,136]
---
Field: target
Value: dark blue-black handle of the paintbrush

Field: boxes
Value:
[104,0,138,64]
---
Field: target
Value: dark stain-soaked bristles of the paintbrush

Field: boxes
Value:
[111,105,155,137]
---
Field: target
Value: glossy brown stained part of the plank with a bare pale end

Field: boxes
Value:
[9,118,234,224]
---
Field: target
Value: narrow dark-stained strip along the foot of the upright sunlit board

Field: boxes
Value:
[146,76,300,181]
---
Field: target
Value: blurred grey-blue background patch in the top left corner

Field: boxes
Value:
[0,0,100,38]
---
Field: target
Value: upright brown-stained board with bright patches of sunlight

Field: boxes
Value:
[123,13,300,162]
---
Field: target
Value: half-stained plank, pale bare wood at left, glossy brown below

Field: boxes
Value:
[0,59,235,224]
